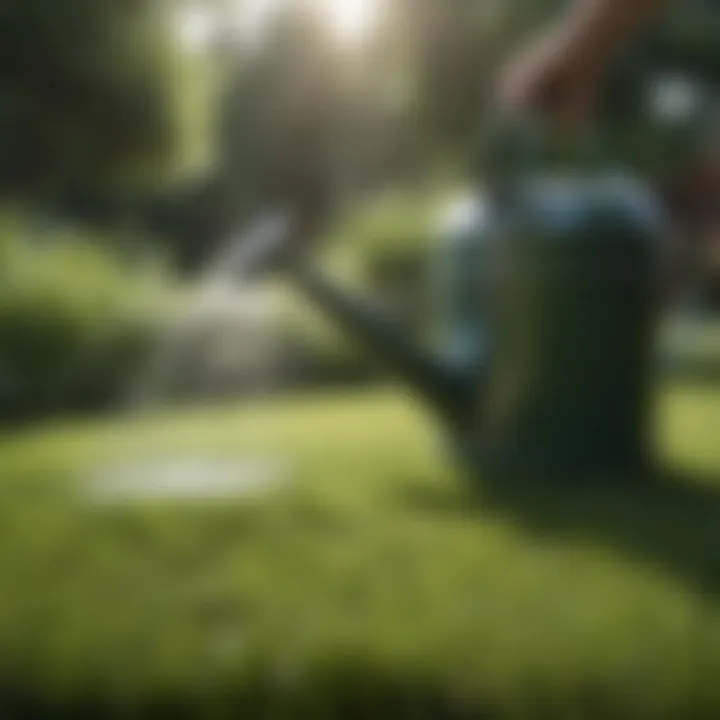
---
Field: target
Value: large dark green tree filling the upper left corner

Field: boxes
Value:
[0,0,208,202]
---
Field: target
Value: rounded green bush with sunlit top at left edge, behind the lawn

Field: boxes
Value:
[0,215,173,420]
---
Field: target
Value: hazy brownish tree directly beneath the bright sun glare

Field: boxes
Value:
[218,2,345,217]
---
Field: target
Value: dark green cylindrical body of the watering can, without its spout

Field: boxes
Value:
[434,174,666,473]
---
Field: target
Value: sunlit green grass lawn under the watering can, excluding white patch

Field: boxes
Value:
[0,387,720,718]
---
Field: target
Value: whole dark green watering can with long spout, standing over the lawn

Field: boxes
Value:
[242,56,716,476]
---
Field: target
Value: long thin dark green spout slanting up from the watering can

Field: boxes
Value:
[291,264,475,429]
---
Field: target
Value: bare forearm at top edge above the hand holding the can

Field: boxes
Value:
[561,0,667,58]
